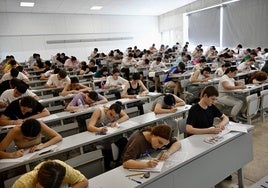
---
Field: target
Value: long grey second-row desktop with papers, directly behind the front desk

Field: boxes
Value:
[0,105,190,172]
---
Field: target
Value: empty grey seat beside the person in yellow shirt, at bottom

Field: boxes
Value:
[65,150,104,179]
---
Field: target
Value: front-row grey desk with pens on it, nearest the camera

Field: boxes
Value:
[88,122,253,188]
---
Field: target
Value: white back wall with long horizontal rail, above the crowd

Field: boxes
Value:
[0,13,160,61]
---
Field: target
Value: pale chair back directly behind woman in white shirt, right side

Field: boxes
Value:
[246,93,260,117]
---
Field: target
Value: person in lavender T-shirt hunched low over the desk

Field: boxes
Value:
[66,91,108,111]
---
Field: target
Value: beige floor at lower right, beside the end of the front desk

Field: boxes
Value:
[216,117,268,188]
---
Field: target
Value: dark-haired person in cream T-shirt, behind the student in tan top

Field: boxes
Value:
[45,70,71,88]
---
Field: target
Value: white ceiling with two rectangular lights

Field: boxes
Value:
[0,0,196,16]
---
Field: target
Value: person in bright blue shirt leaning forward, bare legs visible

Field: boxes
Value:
[165,62,185,95]
